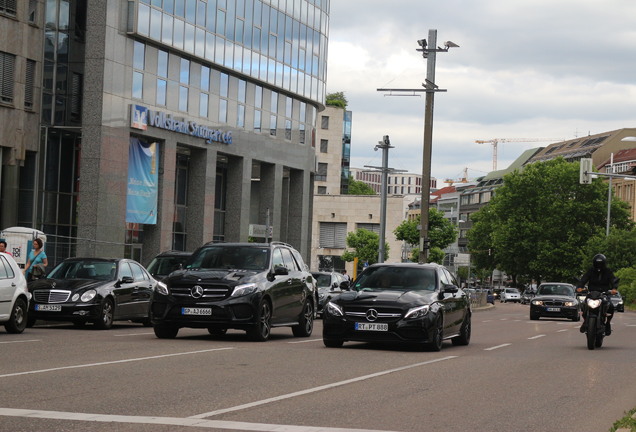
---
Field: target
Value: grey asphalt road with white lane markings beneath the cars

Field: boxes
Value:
[0,303,636,432]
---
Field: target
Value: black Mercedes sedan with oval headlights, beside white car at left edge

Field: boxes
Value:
[29,258,159,330]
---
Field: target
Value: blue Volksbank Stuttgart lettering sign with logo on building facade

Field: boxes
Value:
[130,105,232,145]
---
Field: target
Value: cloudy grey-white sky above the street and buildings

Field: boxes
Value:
[327,0,636,186]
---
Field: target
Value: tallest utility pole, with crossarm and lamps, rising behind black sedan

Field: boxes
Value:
[378,30,459,263]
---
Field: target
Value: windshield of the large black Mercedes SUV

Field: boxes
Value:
[186,245,269,271]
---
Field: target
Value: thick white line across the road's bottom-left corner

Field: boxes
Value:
[0,408,398,432]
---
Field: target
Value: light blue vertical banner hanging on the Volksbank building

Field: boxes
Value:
[126,138,159,225]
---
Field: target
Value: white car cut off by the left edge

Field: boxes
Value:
[0,252,31,333]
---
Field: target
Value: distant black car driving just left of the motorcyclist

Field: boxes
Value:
[530,282,581,321]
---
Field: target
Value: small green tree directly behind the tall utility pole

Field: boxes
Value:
[393,208,457,262]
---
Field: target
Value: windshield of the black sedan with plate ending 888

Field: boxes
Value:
[354,267,437,291]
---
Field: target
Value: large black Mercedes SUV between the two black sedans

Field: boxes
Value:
[151,242,316,341]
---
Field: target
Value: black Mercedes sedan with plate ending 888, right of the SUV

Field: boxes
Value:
[322,263,472,351]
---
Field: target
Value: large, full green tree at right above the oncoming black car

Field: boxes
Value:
[469,158,633,281]
